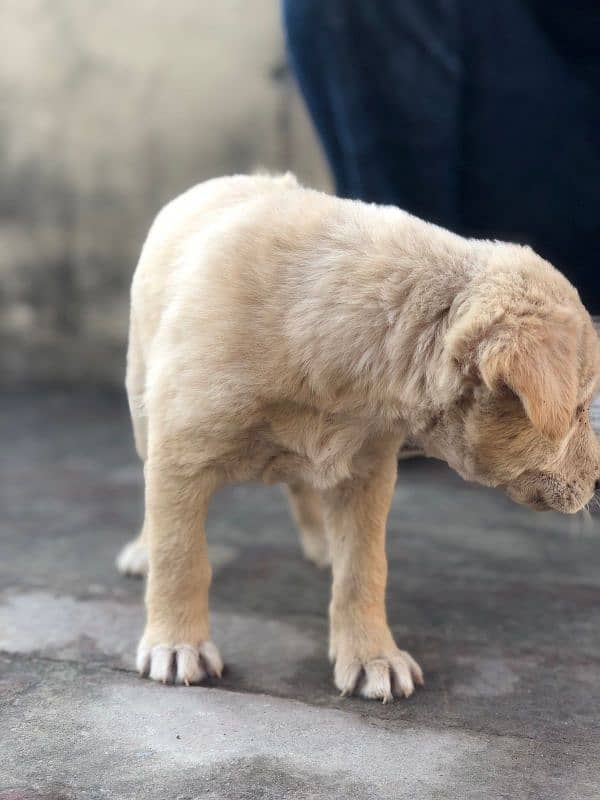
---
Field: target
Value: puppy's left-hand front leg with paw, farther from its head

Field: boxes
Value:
[137,457,223,684]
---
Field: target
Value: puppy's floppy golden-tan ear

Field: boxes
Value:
[478,309,578,441]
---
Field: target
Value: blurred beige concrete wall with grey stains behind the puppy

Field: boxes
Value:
[0,0,328,384]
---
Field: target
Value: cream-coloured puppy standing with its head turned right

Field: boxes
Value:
[119,175,600,702]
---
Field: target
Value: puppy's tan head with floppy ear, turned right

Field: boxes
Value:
[425,244,600,513]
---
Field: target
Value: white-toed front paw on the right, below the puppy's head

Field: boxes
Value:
[334,647,424,703]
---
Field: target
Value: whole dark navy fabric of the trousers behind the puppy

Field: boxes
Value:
[283,0,600,313]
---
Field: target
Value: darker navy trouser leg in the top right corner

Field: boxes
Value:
[461,0,600,314]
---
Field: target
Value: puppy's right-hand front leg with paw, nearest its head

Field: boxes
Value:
[323,448,423,703]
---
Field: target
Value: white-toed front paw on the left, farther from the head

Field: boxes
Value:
[136,639,223,686]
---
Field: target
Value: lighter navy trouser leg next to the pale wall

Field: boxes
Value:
[283,0,461,227]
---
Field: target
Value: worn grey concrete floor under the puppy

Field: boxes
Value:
[0,392,600,800]
